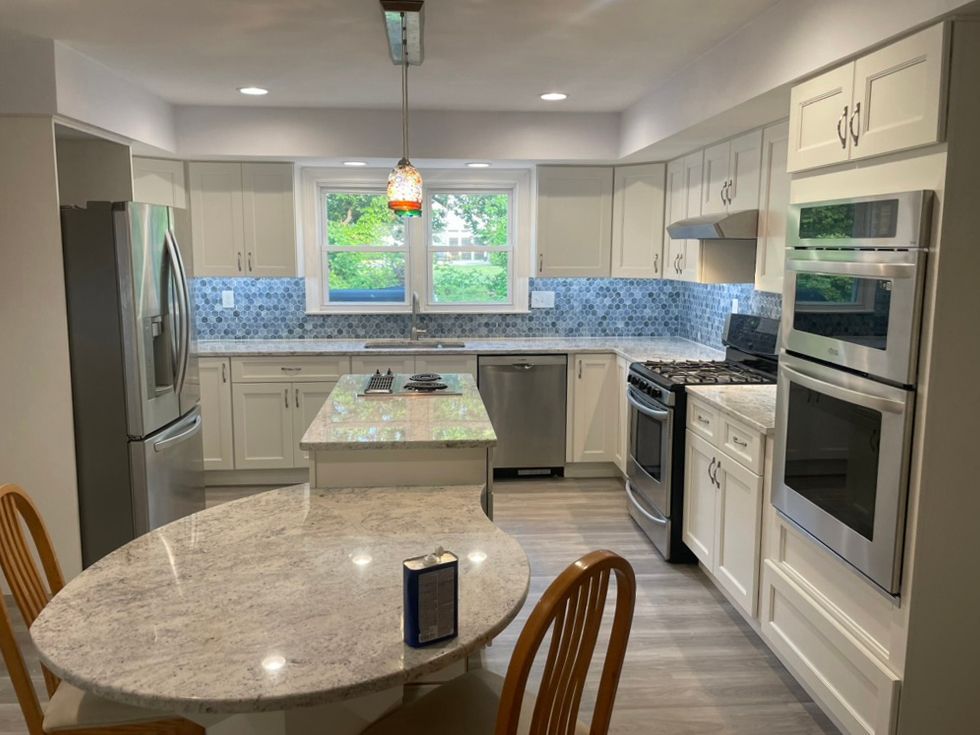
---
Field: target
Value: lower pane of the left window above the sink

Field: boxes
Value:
[327,252,405,304]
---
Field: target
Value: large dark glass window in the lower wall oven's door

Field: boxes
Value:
[783,382,881,541]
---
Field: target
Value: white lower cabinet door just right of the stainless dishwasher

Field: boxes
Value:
[569,355,619,462]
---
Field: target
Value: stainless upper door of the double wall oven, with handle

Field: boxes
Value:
[783,250,926,385]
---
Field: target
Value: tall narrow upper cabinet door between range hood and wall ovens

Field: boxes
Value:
[755,122,790,293]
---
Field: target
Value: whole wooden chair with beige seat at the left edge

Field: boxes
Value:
[0,485,204,735]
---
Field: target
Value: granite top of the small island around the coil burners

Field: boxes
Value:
[299,373,497,451]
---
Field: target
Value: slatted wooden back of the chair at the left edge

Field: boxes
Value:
[0,485,65,735]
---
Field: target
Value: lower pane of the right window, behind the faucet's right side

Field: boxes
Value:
[432,252,510,304]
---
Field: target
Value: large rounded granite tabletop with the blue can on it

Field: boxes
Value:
[31,485,530,714]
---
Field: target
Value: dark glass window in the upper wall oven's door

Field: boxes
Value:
[793,273,892,350]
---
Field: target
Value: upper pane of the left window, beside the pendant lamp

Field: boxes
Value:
[324,191,405,247]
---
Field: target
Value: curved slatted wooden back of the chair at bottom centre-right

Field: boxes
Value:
[496,551,636,735]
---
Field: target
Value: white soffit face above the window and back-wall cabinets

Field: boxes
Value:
[177,107,619,161]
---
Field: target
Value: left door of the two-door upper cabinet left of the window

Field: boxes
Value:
[187,163,246,276]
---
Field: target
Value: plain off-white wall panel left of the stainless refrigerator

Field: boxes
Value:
[0,117,82,577]
